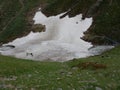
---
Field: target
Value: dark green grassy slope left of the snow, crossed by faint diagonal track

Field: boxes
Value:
[0,0,47,43]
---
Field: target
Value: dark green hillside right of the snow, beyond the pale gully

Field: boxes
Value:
[84,0,120,44]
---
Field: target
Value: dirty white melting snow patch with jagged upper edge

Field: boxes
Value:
[1,11,114,62]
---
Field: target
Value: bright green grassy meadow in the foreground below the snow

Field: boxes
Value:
[0,46,120,90]
